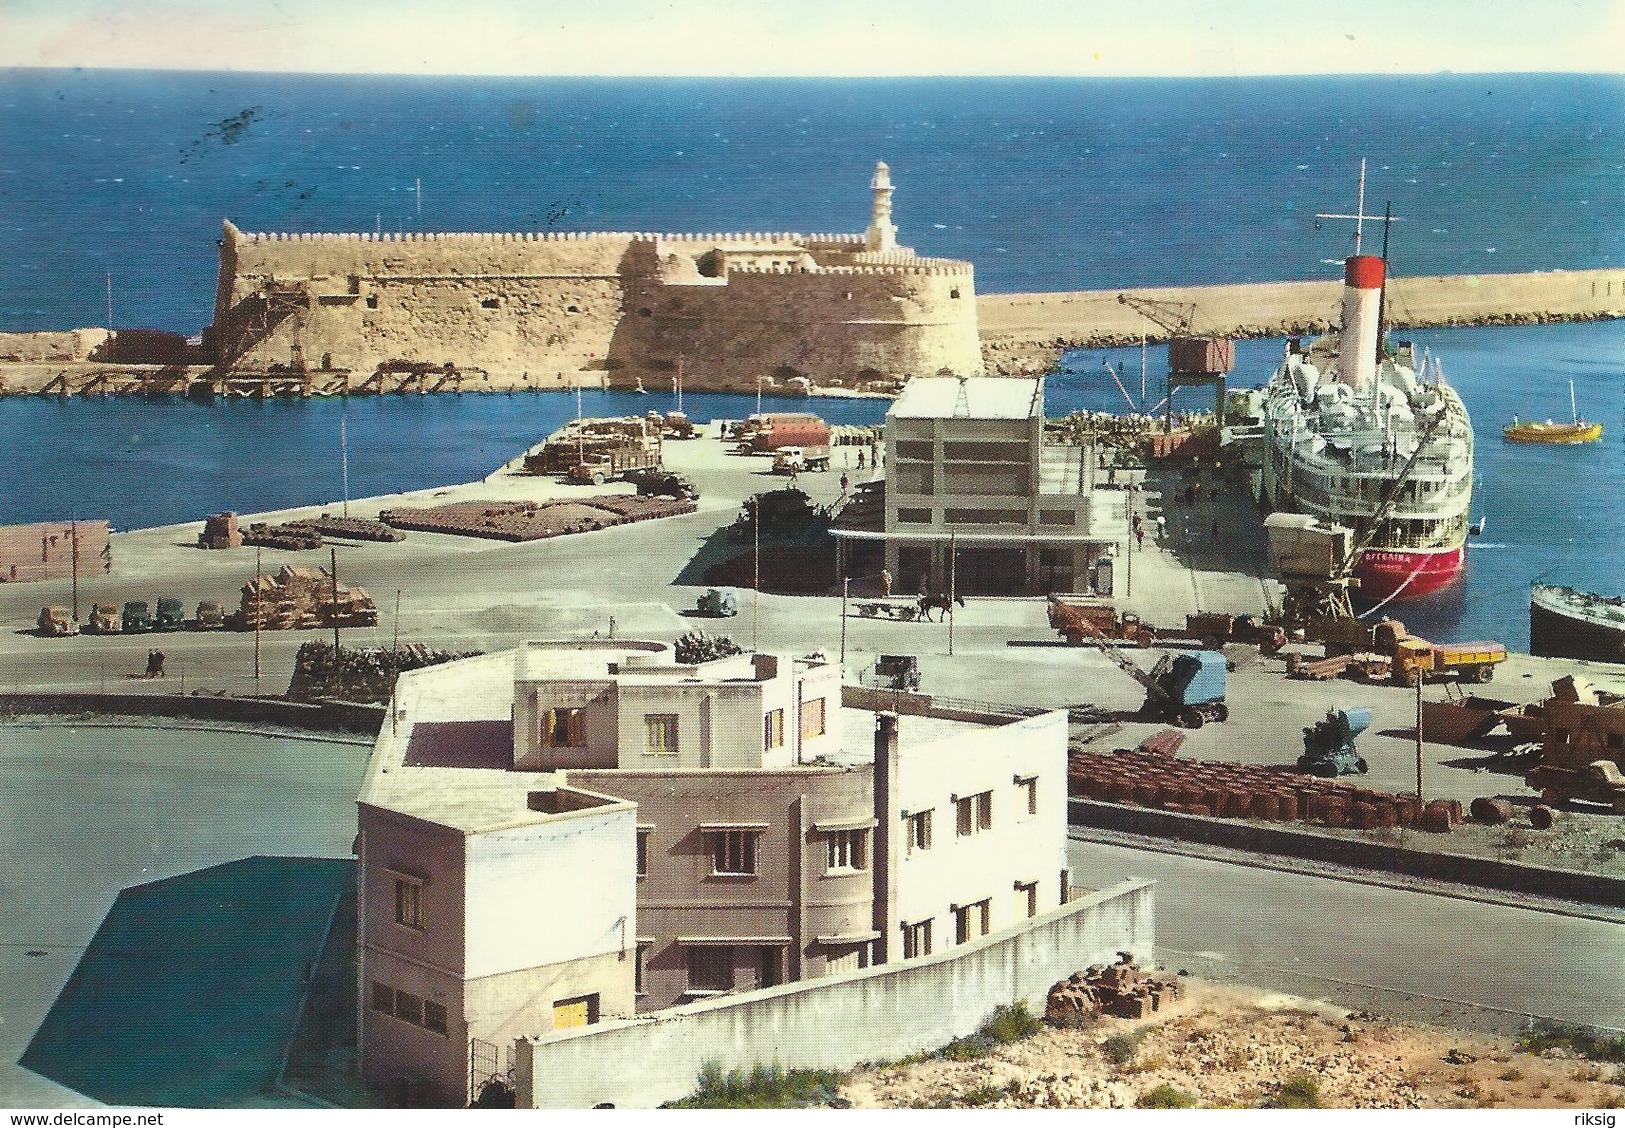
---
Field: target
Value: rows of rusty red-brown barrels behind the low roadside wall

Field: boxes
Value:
[1066,749,1463,832]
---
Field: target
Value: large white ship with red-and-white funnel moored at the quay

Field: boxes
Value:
[1263,253,1472,603]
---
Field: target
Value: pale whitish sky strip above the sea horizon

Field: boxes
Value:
[0,0,1625,78]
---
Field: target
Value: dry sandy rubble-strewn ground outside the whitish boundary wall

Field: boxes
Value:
[840,980,1625,1108]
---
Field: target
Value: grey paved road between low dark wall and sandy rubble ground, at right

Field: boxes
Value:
[1069,840,1625,1029]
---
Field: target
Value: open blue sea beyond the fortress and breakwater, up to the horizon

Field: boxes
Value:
[0,70,1625,333]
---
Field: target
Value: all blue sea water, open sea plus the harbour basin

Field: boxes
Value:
[0,68,1625,645]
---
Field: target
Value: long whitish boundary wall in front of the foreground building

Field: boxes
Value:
[515,879,1155,1108]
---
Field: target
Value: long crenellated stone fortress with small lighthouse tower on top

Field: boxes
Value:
[208,163,982,392]
